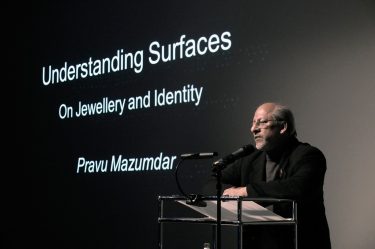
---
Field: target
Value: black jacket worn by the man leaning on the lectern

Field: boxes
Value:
[217,138,331,249]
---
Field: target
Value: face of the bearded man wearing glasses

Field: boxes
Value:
[251,105,281,151]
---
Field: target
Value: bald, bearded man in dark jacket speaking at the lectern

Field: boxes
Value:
[217,103,331,249]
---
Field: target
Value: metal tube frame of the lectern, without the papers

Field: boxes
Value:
[158,196,298,249]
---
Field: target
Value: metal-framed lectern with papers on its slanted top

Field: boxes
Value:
[158,195,298,249]
